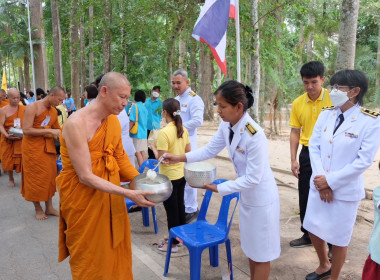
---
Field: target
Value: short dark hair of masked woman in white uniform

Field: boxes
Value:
[330,69,368,105]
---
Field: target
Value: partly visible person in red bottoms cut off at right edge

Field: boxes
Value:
[362,163,380,280]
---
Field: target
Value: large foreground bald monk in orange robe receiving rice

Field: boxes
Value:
[57,72,155,280]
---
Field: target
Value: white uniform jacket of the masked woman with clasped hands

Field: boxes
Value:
[309,106,380,201]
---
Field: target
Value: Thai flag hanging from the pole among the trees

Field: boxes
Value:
[192,0,235,75]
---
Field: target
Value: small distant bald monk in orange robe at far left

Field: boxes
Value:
[0,88,25,188]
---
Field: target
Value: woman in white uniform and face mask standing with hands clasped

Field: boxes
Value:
[304,70,380,280]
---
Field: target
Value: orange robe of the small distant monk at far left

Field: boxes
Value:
[0,105,26,173]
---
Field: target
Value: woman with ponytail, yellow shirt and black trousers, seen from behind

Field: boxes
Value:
[157,98,191,253]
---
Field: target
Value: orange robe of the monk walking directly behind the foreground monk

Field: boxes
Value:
[21,107,60,201]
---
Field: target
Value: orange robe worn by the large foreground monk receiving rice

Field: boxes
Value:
[56,115,139,280]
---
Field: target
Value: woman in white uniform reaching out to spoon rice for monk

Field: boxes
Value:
[164,81,281,279]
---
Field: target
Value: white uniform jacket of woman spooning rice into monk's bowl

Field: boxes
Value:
[186,113,278,206]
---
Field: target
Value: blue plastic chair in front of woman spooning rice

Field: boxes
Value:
[164,179,239,280]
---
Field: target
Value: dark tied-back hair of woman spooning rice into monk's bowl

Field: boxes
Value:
[214,80,254,112]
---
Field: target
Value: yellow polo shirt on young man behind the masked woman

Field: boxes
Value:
[289,88,332,146]
